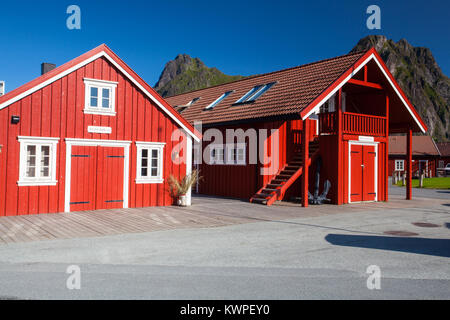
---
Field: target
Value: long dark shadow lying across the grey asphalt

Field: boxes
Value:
[325,234,450,258]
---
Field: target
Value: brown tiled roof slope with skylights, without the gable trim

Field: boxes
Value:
[166,52,366,124]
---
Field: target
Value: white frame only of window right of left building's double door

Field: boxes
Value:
[136,141,166,184]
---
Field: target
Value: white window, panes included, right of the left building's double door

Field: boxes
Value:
[136,142,165,183]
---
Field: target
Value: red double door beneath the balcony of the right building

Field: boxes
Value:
[350,144,377,202]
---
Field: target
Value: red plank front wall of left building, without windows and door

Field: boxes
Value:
[0,58,186,216]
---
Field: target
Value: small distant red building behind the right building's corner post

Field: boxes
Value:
[388,136,440,178]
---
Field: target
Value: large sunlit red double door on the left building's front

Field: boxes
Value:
[70,146,125,211]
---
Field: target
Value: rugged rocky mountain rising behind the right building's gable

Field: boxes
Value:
[351,36,450,141]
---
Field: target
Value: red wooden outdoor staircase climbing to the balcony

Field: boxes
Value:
[250,139,319,206]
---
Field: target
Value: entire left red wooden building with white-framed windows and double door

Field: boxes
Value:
[0,45,200,216]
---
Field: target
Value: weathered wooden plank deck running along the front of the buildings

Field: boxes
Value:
[0,197,439,245]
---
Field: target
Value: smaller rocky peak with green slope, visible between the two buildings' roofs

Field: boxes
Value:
[155,54,243,97]
